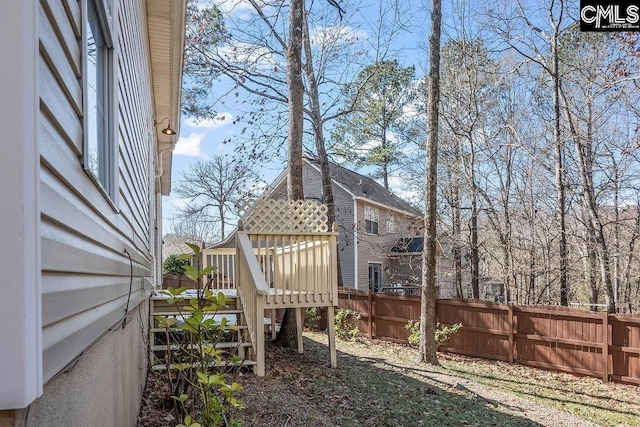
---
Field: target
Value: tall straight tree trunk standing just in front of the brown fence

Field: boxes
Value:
[418,0,442,365]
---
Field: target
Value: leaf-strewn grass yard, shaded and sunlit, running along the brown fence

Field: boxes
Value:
[240,332,640,426]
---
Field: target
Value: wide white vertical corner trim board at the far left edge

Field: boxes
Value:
[0,0,42,409]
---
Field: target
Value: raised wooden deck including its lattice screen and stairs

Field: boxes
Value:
[150,199,338,376]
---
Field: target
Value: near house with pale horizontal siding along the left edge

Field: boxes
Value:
[0,0,186,426]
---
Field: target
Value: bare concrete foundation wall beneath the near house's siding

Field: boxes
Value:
[14,300,149,427]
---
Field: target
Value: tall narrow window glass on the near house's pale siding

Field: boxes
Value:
[84,0,115,198]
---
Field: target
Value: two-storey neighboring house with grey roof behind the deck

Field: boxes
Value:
[263,156,423,291]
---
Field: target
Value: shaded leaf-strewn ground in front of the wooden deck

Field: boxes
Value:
[242,338,540,427]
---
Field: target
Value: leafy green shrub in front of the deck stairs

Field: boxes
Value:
[155,243,242,427]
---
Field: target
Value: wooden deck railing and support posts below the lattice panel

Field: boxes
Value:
[195,217,338,376]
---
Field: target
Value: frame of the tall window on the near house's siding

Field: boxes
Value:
[81,0,118,204]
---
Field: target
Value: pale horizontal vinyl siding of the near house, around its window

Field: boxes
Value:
[39,0,155,381]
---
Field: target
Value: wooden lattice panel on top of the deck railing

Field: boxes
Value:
[241,199,328,233]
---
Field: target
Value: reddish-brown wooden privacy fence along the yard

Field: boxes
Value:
[338,289,640,385]
